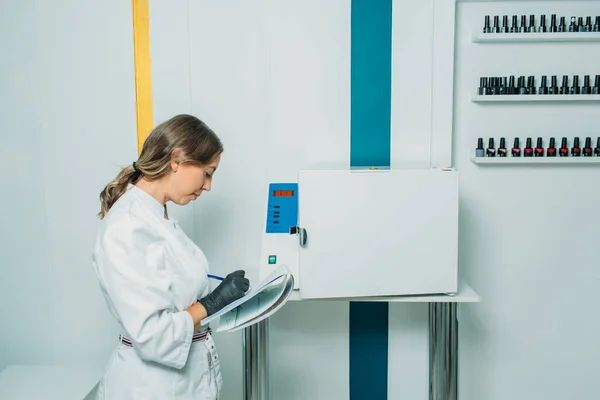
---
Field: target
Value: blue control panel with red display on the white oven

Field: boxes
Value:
[267,183,298,234]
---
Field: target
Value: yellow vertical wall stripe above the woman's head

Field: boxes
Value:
[132,0,153,154]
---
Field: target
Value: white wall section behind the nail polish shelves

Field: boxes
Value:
[453,1,600,400]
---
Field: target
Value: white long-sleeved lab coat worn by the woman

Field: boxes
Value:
[93,185,222,400]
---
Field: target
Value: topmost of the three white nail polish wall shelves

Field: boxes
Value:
[471,32,600,43]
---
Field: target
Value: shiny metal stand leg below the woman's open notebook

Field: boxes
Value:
[243,318,270,400]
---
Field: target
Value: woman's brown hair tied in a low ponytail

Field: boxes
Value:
[98,114,223,219]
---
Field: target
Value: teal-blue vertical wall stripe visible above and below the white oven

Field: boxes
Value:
[349,0,392,400]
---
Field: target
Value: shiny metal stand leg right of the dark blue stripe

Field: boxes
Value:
[429,303,458,400]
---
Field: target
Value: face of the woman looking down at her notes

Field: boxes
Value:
[169,154,221,206]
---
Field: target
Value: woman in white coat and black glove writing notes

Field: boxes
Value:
[93,115,249,400]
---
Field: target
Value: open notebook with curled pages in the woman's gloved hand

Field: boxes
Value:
[201,265,294,332]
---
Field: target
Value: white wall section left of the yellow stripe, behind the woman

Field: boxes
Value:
[0,0,137,370]
